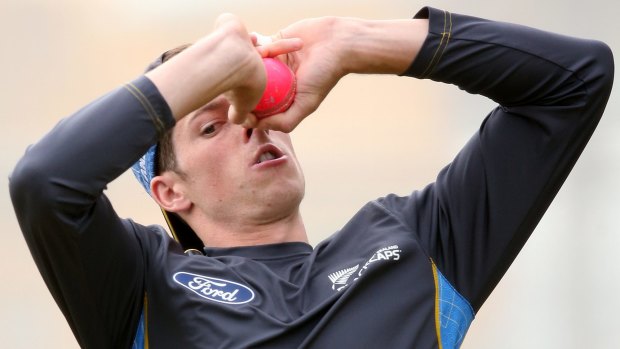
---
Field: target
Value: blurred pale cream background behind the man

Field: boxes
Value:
[0,0,620,349]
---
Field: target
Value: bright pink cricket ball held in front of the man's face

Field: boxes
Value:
[253,58,297,119]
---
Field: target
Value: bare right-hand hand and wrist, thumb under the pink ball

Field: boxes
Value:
[247,17,428,132]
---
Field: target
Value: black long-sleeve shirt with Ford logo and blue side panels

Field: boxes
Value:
[10,8,613,348]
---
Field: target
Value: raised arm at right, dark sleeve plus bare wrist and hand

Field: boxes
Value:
[259,8,613,310]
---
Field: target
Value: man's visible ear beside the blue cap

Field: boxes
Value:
[151,172,191,213]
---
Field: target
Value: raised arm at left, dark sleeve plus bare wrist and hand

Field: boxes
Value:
[10,15,284,348]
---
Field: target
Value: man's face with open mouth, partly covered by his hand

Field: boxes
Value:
[161,96,304,224]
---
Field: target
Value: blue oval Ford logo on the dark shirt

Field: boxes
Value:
[172,272,254,304]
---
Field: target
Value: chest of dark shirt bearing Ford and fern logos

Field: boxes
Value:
[146,234,436,348]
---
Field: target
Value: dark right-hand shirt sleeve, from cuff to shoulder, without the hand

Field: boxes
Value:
[394,9,613,310]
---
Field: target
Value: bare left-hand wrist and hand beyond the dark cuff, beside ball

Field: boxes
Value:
[146,15,266,120]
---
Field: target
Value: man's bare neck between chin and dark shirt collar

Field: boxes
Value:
[193,210,308,247]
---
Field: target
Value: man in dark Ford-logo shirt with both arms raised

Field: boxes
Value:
[11,8,613,348]
